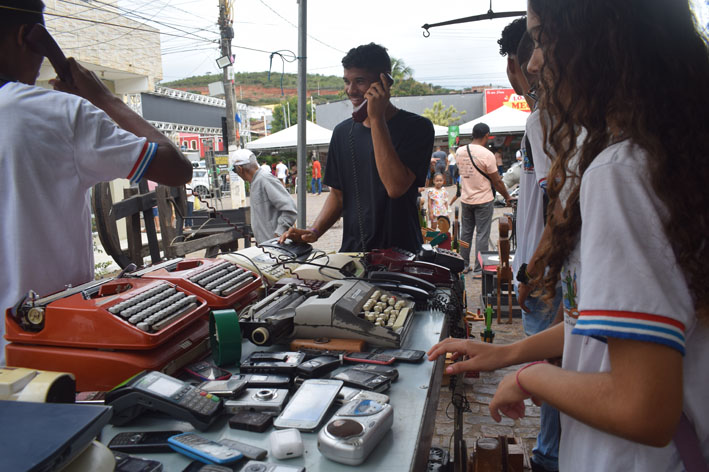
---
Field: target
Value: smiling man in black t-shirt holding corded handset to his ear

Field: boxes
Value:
[281,43,434,252]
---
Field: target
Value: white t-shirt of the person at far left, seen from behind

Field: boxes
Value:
[0,82,157,365]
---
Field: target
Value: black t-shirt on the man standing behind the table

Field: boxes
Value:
[324,110,434,252]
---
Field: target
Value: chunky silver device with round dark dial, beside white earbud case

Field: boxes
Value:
[318,400,394,465]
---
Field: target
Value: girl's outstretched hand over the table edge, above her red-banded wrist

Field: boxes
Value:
[428,338,507,374]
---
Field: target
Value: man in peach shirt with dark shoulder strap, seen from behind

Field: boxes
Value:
[455,123,510,278]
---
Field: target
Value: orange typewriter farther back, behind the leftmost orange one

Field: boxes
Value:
[133,258,261,311]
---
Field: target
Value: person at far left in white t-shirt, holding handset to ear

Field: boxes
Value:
[0,0,192,365]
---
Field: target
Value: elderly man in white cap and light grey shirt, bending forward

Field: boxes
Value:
[229,149,298,244]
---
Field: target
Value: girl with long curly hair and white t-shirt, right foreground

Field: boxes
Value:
[429,0,709,472]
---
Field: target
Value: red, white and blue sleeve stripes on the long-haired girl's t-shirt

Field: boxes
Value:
[571,310,685,355]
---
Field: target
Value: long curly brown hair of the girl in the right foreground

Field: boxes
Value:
[529,0,709,321]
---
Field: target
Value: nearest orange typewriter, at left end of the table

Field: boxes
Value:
[5,278,209,391]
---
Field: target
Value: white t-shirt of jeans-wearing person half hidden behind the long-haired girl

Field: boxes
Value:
[512,110,551,284]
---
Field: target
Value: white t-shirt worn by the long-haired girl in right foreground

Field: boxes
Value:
[559,141,709,472]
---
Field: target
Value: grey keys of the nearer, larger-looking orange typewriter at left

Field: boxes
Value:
[108,283,199,333]
